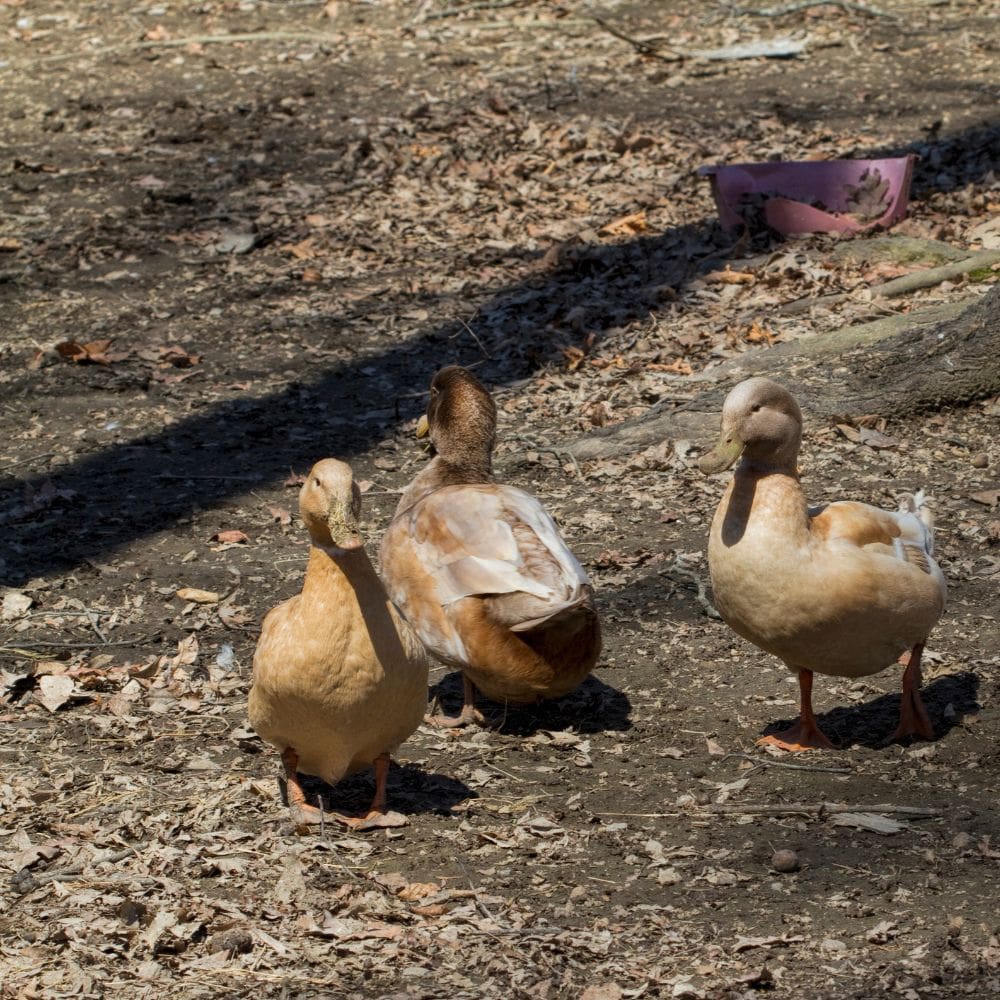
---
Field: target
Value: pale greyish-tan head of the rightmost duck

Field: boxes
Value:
[698,378,802,475]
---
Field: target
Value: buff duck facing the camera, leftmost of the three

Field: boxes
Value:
[249,458,427,828]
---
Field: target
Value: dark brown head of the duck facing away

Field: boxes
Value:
[417,365,497,473]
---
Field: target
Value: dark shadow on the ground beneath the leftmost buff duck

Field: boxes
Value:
[292,761,478,816]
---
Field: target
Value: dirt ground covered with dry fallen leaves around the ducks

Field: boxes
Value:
[0,0,1000,1000]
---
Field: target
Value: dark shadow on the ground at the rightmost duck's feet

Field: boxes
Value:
[761,671,980,750]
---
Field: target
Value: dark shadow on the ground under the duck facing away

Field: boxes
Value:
[431,671,632,736]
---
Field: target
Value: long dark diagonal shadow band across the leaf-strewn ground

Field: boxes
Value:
[0,99,1000,586]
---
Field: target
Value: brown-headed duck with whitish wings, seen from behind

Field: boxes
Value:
[380,365,601,727]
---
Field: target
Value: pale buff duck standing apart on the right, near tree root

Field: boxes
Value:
[699,378,946,750]
